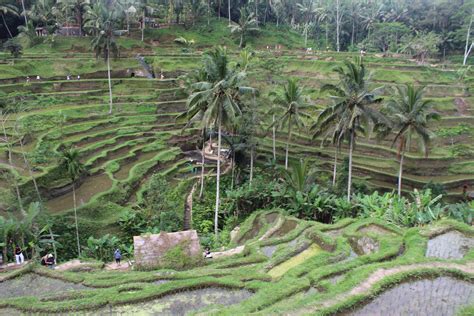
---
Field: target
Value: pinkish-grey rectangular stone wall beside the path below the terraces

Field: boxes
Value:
[133,230,202,267]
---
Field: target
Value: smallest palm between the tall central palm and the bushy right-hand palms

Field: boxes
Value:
[273,78,309,169]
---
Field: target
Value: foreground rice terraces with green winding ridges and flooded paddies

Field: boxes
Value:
[0,210,474,315]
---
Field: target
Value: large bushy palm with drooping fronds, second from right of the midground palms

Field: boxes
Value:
[312,59,386,201]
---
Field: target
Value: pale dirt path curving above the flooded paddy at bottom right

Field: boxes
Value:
[292,262,474,315]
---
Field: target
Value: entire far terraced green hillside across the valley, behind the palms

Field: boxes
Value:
[0,29,474,232]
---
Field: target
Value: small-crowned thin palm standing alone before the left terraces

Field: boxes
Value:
[61,148,85,256]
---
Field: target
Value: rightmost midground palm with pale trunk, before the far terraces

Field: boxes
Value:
[385,84,440,196]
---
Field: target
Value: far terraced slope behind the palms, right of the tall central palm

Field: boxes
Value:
[248,52,474,197]
